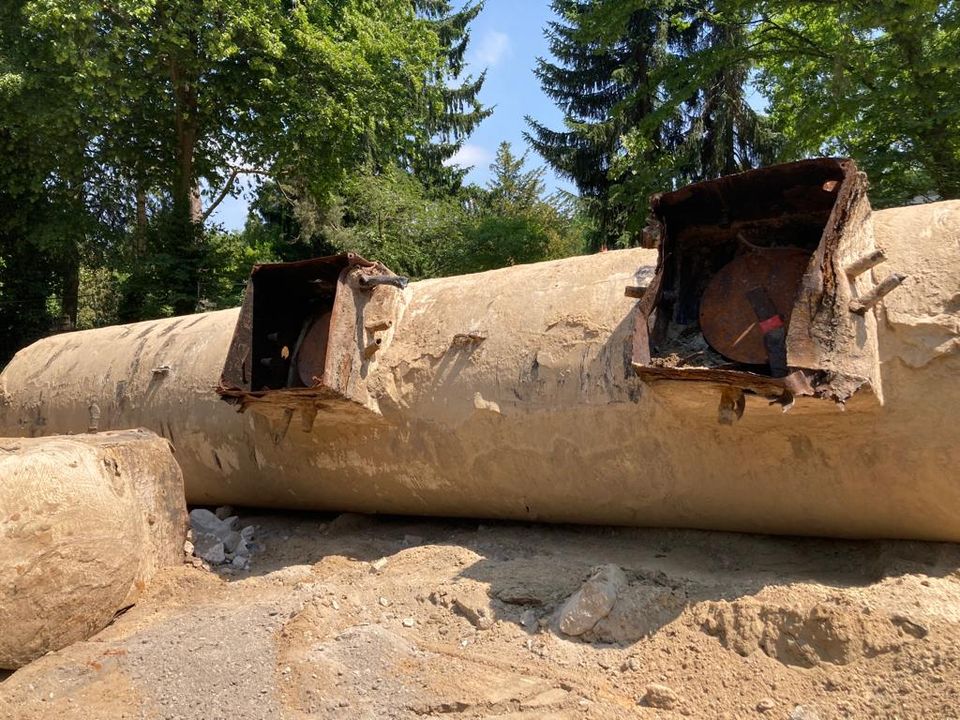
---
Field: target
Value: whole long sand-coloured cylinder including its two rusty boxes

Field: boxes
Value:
[0,160,960,540]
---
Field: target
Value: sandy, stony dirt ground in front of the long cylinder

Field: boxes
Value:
[0,514,960,720]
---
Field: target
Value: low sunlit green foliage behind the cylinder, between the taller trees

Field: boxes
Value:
[243,143,585,278]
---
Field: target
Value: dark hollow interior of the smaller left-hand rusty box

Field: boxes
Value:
[250,256,346,392]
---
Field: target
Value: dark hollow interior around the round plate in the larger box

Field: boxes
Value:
[650,159,843,374]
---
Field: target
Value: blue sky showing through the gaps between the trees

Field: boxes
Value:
[213,0,573,229]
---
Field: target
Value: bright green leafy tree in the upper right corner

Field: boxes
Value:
[750,0,960,207]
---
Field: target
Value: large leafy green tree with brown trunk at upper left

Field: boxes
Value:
[0,0,439,313]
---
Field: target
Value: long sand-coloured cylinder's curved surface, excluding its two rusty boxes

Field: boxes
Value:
[0,202,960,541]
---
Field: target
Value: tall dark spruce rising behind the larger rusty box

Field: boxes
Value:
[528,0,775,249]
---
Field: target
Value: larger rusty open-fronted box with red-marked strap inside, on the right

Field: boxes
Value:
[633,158,878,402]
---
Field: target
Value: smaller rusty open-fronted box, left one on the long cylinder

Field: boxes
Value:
[218,253,406,420]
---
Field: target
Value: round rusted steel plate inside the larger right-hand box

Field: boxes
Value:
[700,248,810,365]
